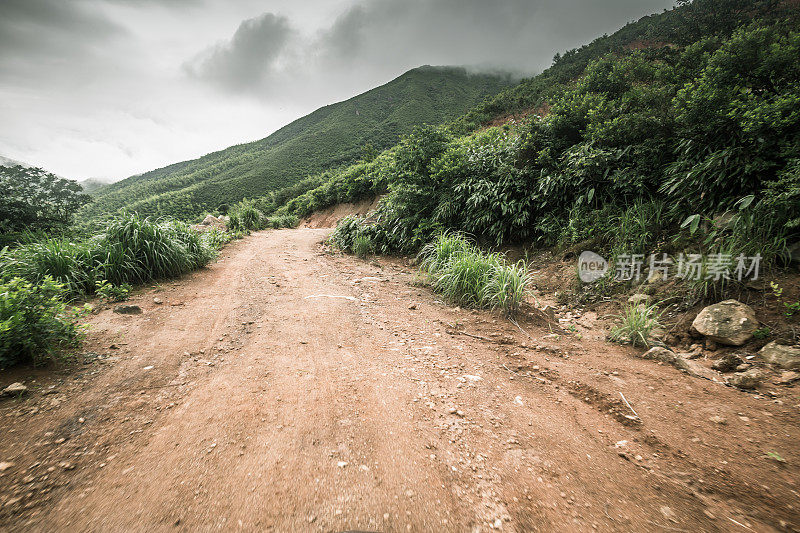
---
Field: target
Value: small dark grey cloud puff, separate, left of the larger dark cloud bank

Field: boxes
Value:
[184,13,295,91]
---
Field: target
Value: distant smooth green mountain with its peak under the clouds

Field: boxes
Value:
[80,66,512,219]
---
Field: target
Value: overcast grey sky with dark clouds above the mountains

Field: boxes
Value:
[0,0,673,179]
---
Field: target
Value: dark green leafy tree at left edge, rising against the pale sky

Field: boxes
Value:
[0,165,90,233]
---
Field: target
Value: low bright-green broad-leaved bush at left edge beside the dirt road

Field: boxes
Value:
[0,277,85,368]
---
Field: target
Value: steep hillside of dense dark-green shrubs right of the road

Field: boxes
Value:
[277,0,800,288]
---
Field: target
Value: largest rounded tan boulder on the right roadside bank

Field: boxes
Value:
[692,300,758,346]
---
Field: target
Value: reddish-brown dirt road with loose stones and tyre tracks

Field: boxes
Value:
[0,229,800,531]
